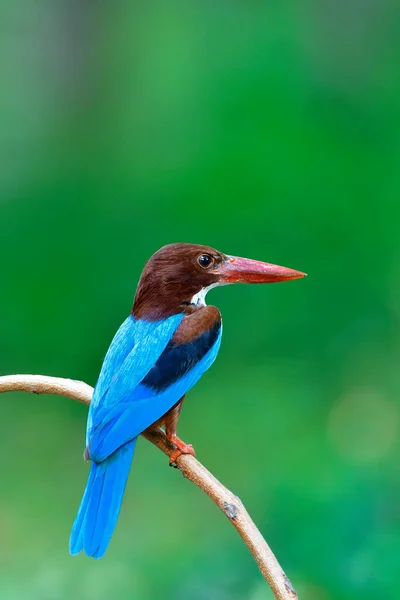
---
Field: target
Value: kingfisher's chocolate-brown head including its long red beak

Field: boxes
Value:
[132,243,305,320]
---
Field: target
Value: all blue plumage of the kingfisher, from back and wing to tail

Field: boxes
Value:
[70,314,222,558]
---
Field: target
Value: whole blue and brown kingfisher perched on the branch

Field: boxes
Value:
[70,243,305,559]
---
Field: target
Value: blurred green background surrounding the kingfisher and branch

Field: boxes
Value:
[0,0,400,600]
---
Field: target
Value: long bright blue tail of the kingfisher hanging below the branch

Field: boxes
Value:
[69,438,136,558]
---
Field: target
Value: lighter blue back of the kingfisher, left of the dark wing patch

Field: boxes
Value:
[86,314,182,444]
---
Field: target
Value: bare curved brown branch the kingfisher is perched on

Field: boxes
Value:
[0,375,297,600]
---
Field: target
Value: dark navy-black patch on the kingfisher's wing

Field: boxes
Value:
[141,317,221,392]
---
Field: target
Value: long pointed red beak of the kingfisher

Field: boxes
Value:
[219,256,306,283]
